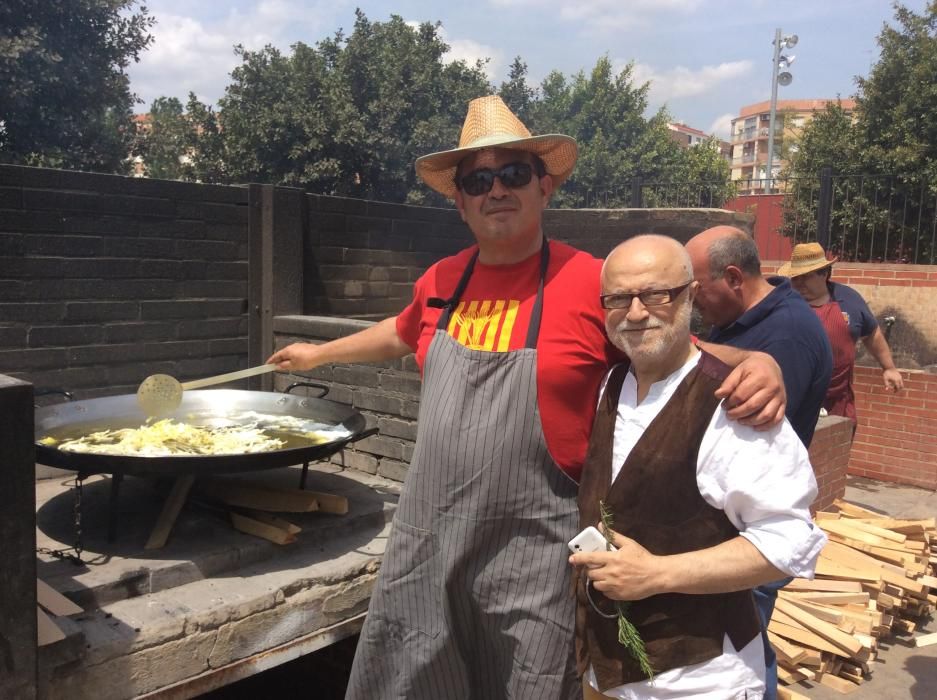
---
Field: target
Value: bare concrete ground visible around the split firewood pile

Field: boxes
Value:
[792,477,937,700]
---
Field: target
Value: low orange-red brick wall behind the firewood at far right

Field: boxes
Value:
[849,367,937,489]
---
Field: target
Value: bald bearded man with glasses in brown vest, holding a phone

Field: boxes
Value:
[570,235,826,700]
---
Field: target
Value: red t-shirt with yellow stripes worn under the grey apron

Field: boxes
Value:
[397,241,621,481]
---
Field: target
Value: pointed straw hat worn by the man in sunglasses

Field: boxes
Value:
[416,95,578,199]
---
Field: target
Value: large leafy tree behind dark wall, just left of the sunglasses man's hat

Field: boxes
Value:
[220,10,490,203]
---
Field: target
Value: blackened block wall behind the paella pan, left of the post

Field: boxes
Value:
[0,165,247,398]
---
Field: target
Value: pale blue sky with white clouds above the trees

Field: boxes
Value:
[122,0,926,137]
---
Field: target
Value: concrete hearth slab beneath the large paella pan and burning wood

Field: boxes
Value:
[37,464,399,700]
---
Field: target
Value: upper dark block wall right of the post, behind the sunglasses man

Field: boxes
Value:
[303,195,753,318]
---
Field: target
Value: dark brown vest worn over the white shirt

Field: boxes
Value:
[576,353,760,690]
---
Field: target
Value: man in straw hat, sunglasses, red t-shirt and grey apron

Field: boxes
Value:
[268,97,783,700]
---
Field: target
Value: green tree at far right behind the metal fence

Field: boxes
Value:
[784,0,937,263]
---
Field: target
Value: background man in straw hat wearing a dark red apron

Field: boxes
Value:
[778,243,904,426]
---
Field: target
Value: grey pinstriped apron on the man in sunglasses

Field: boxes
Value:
[346,242,582,700]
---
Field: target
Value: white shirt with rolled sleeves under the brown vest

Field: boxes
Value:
[587,353,826,700]
